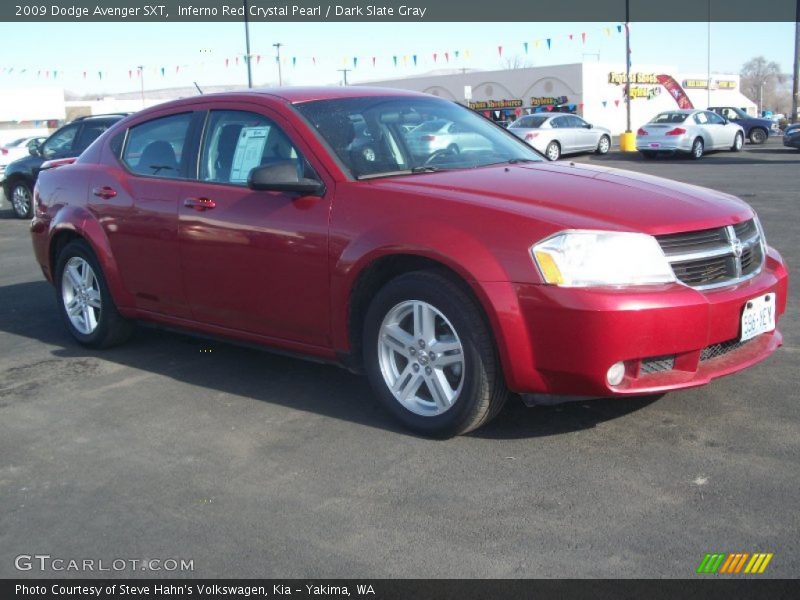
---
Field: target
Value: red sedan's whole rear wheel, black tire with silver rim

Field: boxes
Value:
[55,240,133,348]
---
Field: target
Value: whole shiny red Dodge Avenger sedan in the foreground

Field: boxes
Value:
[31,88,787,435]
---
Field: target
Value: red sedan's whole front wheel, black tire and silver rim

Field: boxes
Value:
[363,271,508,437]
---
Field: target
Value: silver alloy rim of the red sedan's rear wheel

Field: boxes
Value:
[61,256,102,335]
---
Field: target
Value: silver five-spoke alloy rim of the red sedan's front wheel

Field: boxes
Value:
[378,300,465,417]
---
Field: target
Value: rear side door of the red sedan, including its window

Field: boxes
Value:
[88,108,198,318]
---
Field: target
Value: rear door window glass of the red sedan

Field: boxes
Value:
[122,113,192,179]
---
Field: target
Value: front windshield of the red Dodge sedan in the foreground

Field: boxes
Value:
[295,96,542,178]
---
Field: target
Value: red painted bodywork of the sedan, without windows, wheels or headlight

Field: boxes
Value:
[32,88,788,395]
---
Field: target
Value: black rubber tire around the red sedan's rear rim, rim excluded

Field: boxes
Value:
[55,240,134,348]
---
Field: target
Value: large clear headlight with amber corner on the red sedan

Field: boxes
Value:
[530,230,675,287]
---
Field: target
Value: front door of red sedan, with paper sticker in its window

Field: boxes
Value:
[179,103,332,347]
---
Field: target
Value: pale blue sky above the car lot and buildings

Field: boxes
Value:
[0,20,795,96]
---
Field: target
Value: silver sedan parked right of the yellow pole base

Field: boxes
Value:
[636,109,744,159]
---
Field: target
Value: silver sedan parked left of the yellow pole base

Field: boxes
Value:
[508,113,611,160]
